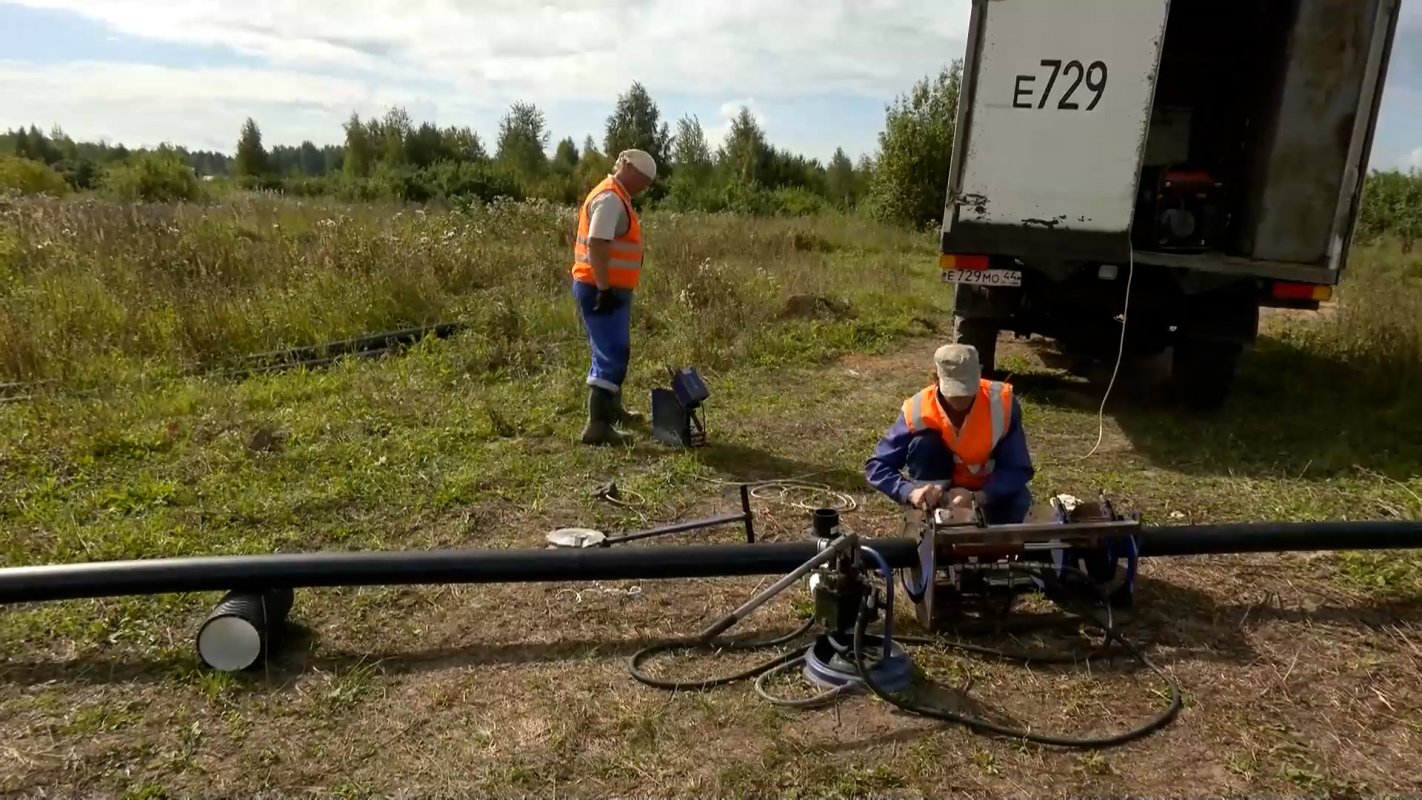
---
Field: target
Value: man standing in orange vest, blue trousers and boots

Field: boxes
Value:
[573,149,657,445]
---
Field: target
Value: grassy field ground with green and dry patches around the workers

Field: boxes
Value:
[0,199,1422,797]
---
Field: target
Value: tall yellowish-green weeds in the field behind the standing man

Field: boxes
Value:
[0,195,947,384]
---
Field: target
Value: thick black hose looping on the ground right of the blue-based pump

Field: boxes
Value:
[855,561,1185,749]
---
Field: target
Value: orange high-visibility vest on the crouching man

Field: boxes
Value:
[903,381,1012,492]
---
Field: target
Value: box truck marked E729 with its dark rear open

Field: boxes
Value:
[939,0,1399,411]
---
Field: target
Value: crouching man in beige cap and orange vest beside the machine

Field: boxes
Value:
[865,344,1034,524]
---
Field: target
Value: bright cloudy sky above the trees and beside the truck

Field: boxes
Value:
[0,0,1422,169]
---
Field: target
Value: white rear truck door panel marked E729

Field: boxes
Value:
[943,0,1170,268]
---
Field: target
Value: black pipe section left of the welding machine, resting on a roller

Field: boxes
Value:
[0,539,917,604]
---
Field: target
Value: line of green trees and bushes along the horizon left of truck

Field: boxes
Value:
[0,63,961,223]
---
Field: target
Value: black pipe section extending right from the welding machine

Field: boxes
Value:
[1138,520,1422,557]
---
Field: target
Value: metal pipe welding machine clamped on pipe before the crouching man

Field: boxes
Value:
[907,493,1140,631]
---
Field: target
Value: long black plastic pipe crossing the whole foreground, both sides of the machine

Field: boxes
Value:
[0,521,1422,604]
